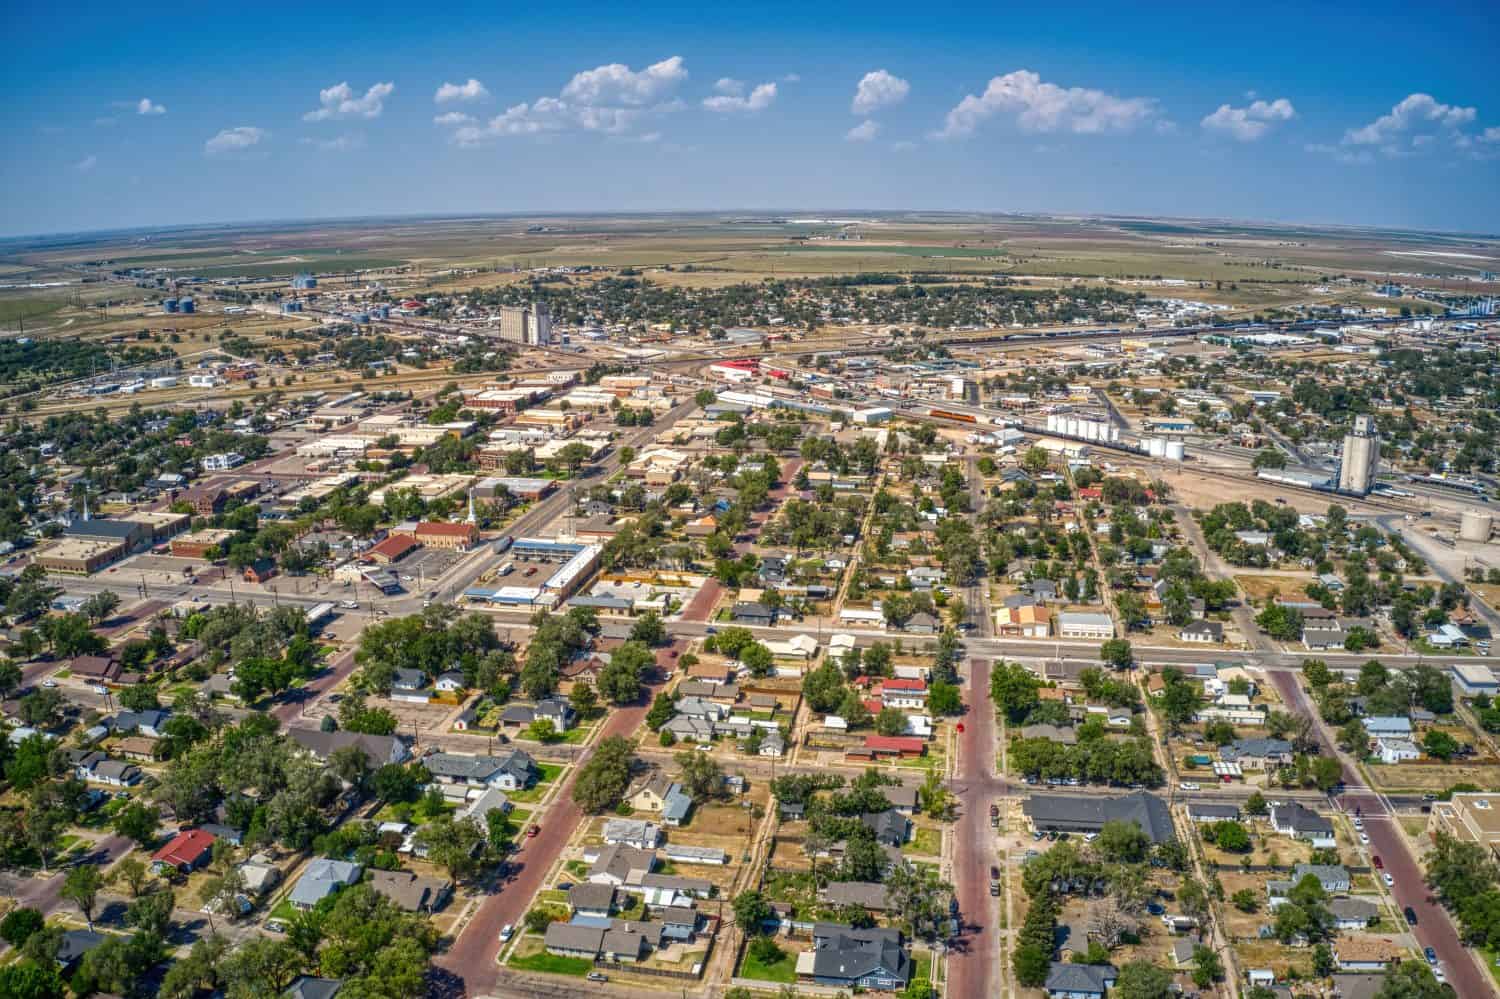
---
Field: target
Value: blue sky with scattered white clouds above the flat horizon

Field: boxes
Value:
[0,3,1500,234]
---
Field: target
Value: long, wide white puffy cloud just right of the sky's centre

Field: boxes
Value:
[938,69,1157,138]
